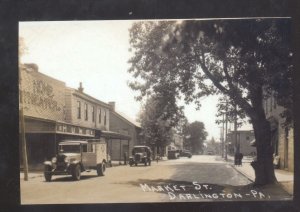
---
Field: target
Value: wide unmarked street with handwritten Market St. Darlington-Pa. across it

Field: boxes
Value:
[20,155,290,204]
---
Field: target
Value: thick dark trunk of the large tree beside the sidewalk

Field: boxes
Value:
[251,117,277,186]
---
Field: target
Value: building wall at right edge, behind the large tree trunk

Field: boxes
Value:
[264,95,294,171]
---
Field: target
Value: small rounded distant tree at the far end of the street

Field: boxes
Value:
[184,121,207,153]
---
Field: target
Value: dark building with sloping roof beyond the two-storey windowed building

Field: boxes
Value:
[108,102,141,160]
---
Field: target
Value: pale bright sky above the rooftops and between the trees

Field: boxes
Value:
[19,20,251,140]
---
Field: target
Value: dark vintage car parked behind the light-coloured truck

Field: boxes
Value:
[129,146,152,166]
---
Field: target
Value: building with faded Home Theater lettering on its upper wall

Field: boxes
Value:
[20,64,65,166]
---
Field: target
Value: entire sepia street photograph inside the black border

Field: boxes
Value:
[18,17,294,205]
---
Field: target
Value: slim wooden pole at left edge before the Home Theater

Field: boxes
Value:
[19,66,28,181]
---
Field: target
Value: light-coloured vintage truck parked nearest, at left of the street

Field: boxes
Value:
[44,139,107,182]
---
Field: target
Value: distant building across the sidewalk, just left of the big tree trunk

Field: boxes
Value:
[227,130,256,155]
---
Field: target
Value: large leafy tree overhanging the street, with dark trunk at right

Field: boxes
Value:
[129,19,293,185]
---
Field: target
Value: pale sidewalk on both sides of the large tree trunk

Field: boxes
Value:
[227,156,294,195]
